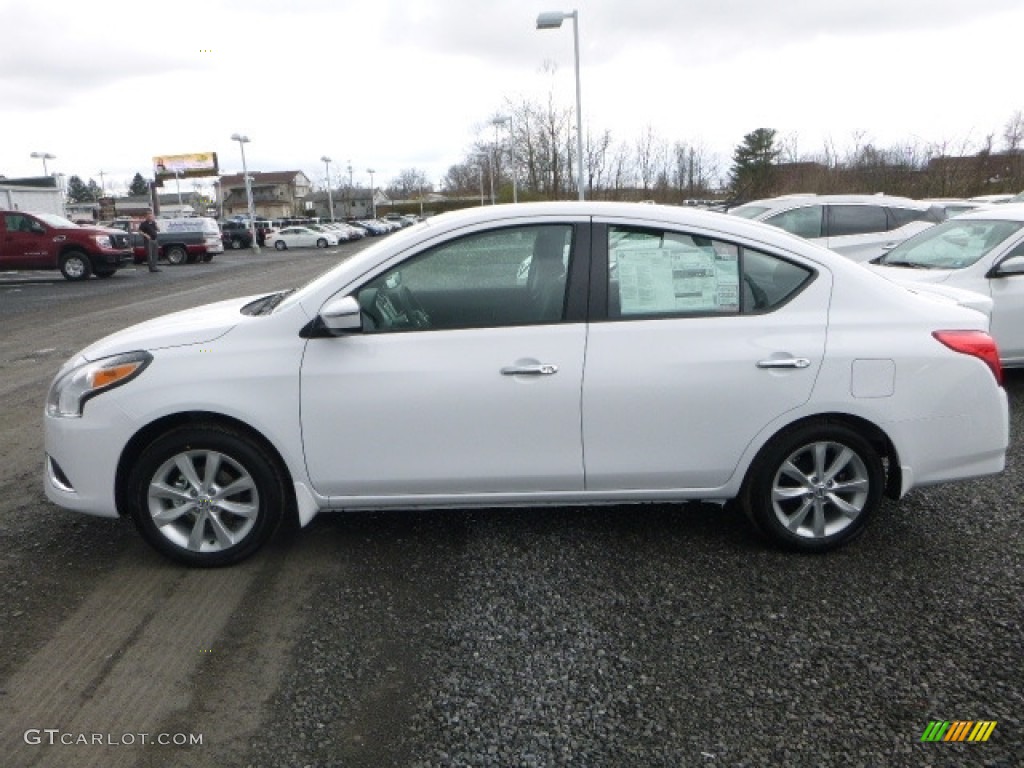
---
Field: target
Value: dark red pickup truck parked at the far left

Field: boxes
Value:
[0,211,132,281]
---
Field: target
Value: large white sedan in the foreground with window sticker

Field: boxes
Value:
[44,202,1009,566]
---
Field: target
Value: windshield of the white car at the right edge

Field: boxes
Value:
[879,219,1024,269]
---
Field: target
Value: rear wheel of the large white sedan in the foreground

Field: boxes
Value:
[740,422,885,552]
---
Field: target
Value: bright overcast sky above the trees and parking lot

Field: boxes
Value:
[0,0,1024,198]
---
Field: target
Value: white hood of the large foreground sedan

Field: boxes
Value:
[81,296,259,360]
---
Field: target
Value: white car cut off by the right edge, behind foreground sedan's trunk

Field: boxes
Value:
[867,204,1024,368]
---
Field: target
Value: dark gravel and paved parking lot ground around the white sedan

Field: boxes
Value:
[0,244,1024,768]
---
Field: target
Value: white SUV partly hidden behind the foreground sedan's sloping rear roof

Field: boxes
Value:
[729,195,943,261]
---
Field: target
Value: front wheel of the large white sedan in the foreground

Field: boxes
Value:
[128,424,287,567]
